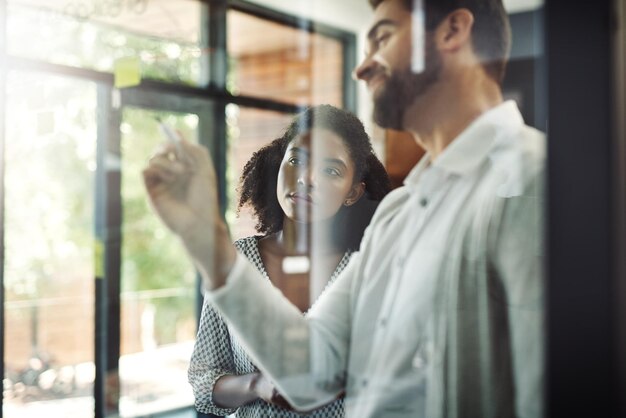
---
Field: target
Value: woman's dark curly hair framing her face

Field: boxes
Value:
[238,105,390,250]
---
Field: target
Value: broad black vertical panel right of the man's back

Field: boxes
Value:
[545,0,626,417]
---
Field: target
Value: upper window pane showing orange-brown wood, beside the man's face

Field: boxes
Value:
[227,10,343,107]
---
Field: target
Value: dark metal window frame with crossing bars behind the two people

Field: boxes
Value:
[0,0,356,418]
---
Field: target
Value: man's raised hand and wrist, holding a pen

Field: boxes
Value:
[143,140,235,289]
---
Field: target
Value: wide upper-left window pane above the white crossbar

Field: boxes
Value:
[7,0,207,84]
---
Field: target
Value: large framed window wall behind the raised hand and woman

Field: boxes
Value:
[0,0,356,418]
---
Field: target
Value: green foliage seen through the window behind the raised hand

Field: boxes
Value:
[121,108,197,342]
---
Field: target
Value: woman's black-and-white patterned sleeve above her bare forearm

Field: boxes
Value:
[188,299,236,416]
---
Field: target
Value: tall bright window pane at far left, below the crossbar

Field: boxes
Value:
[3,73,96,417]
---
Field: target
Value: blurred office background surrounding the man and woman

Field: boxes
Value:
[0,0,626,418]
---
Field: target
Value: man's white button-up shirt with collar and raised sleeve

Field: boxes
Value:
[207,102,545,418]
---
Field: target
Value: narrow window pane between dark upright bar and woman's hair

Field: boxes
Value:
[226,104,293,240]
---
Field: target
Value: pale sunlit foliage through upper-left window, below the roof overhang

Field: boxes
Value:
[7,4,205,84]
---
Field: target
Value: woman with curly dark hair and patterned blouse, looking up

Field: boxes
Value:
[189,105,390,418]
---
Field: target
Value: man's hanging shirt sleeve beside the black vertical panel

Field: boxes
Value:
[492,170,545,418]
